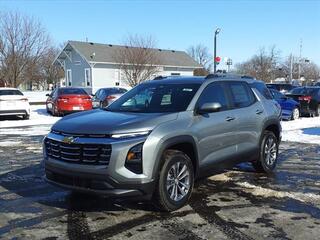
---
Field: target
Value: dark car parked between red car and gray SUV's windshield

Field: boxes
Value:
[92,88,127,108]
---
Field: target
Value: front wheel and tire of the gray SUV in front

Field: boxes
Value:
[153,150,194,212]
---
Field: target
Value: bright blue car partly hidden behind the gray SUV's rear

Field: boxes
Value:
[269,88,300,120]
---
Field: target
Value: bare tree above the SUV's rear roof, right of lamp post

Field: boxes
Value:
[236,46,280,82]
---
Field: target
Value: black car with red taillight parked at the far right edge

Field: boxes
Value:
[286,87,320,117]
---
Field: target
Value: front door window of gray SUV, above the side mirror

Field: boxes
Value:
[197,83,228,110]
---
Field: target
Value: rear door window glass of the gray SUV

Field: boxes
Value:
[228,83,255,108]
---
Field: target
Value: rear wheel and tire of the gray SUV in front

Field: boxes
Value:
[252,131,279,173]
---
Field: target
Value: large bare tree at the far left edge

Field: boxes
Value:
[0,12,50,87]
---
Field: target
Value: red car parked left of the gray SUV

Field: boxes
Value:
[46,87,92,116]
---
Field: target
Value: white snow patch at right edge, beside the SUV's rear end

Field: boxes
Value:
[281,117,320,144]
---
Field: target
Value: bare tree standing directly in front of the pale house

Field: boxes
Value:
[113,35,160,87]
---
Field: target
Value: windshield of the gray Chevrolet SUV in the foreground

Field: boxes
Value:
[107,83,200,113]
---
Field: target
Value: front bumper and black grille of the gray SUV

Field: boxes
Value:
[44,133,154,199]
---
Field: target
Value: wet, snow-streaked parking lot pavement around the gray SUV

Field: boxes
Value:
[0,127,320,240]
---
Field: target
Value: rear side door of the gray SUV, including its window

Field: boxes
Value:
[226,81,266,158]
